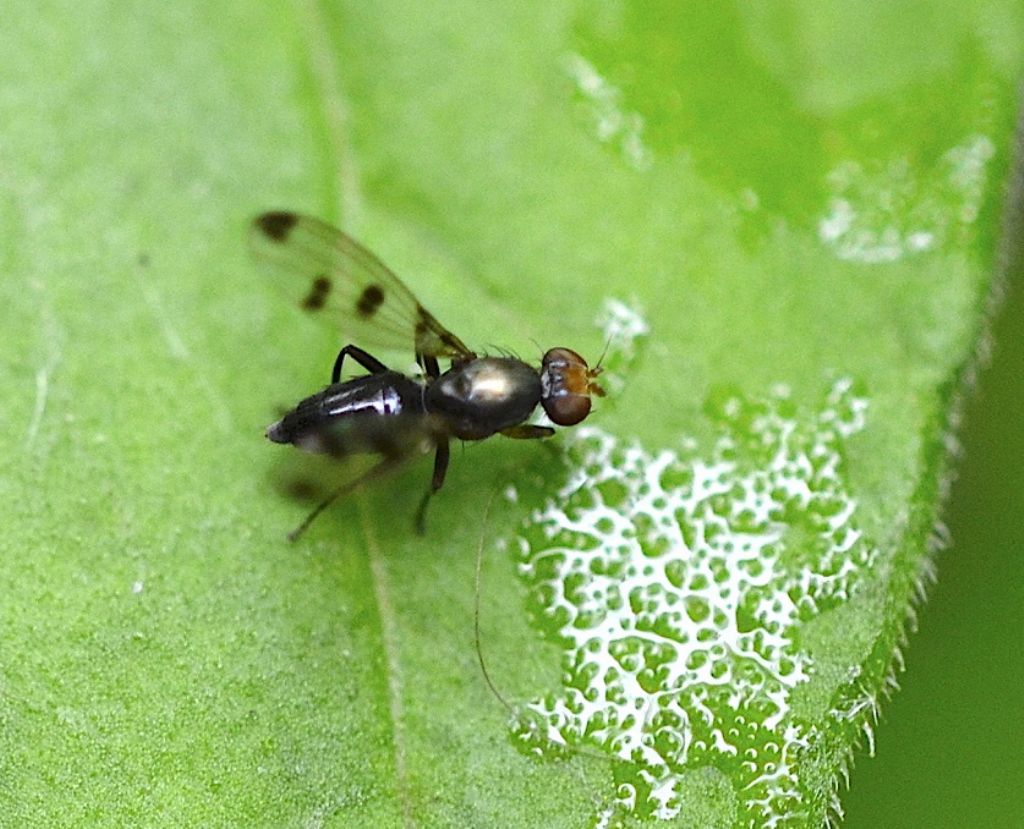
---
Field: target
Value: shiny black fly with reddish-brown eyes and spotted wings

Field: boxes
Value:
[250,211,604,540]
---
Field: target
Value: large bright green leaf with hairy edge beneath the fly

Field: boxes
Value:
[0,0,1024,827]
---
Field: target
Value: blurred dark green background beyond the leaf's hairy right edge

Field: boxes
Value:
[843,166,1024,829]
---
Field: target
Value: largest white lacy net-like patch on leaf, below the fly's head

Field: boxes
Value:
[516,380,876,826]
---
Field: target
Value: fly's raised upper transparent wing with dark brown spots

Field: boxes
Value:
[250,211,472,358]
